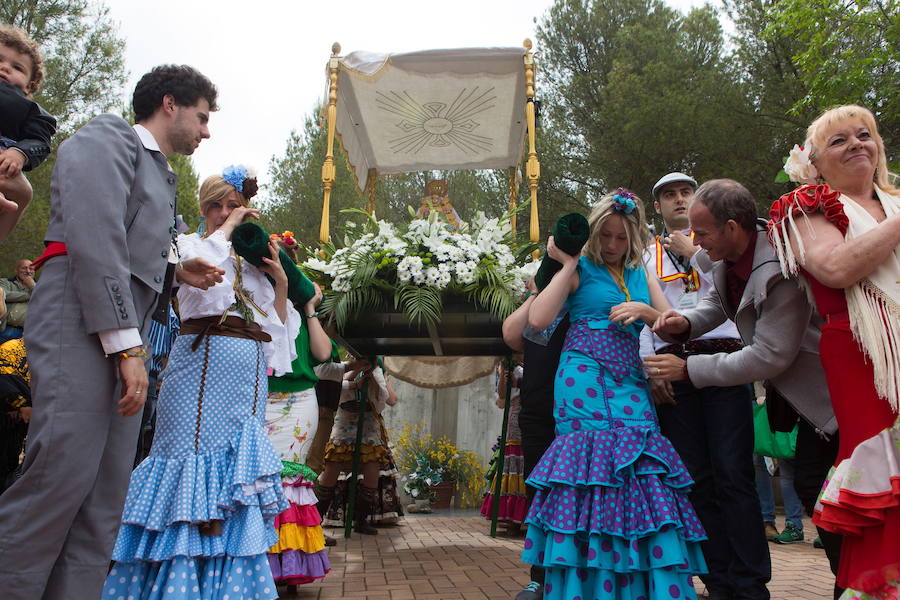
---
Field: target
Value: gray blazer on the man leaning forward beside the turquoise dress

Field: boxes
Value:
[684,220,837,435]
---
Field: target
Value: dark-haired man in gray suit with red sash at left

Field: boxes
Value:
[0,65,221,600]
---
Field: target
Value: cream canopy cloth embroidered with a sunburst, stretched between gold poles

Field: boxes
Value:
[336,48,526,189]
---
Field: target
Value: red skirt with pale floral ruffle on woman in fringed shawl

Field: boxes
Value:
[813,321,900,600]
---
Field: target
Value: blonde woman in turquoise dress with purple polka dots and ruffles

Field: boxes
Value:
[523,188,706,600]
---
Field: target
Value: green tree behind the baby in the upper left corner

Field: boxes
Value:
[0,0,125,274]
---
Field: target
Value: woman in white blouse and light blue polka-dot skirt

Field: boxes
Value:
[102,168,300,600]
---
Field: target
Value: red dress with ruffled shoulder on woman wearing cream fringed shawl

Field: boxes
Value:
[769,186,900,598]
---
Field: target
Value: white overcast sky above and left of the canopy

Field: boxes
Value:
[106,0,702,192]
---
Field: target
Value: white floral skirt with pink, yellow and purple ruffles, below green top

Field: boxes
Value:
[266,389,331,585]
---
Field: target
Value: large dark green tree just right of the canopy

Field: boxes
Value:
[538,0,772,218]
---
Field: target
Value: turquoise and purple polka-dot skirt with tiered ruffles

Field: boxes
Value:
[522,342,706,600]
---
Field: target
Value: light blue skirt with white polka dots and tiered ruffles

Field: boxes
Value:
[103,335,288,600]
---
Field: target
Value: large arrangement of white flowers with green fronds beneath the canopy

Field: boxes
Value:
[303,210,538,326]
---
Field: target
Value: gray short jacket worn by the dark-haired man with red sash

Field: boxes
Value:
[35,115,176,333]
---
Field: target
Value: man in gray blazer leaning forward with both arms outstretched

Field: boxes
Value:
[644,179,840,598]
